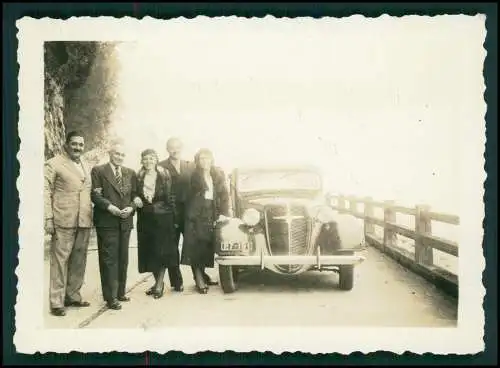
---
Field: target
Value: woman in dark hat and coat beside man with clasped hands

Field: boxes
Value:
[137,149,179,299]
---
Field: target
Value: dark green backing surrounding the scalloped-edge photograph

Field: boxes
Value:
[2,2,498,365]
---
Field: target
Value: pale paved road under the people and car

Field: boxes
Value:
[47,231,457,329]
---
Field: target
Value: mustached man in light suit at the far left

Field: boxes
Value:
[44,131,92,316]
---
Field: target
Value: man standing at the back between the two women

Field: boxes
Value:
[159,137,217,291]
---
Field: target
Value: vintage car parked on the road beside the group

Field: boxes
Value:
[215,166,365,293]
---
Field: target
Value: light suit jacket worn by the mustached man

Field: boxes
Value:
[44,153,92,228]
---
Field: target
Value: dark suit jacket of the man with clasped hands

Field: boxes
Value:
[91,162,137,229]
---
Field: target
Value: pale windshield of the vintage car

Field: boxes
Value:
[238,170,321,192]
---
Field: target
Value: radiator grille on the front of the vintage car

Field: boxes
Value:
[266,206,308,255]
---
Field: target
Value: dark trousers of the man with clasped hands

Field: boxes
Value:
[96,228,131,303]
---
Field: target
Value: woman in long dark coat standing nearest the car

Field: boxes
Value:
[181,149,229,294]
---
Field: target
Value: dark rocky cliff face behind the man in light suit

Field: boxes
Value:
[44,41,117,160]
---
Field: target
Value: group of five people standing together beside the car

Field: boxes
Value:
[44,131,229,316]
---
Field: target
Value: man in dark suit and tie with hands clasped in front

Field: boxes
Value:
[91,143,138,310]
